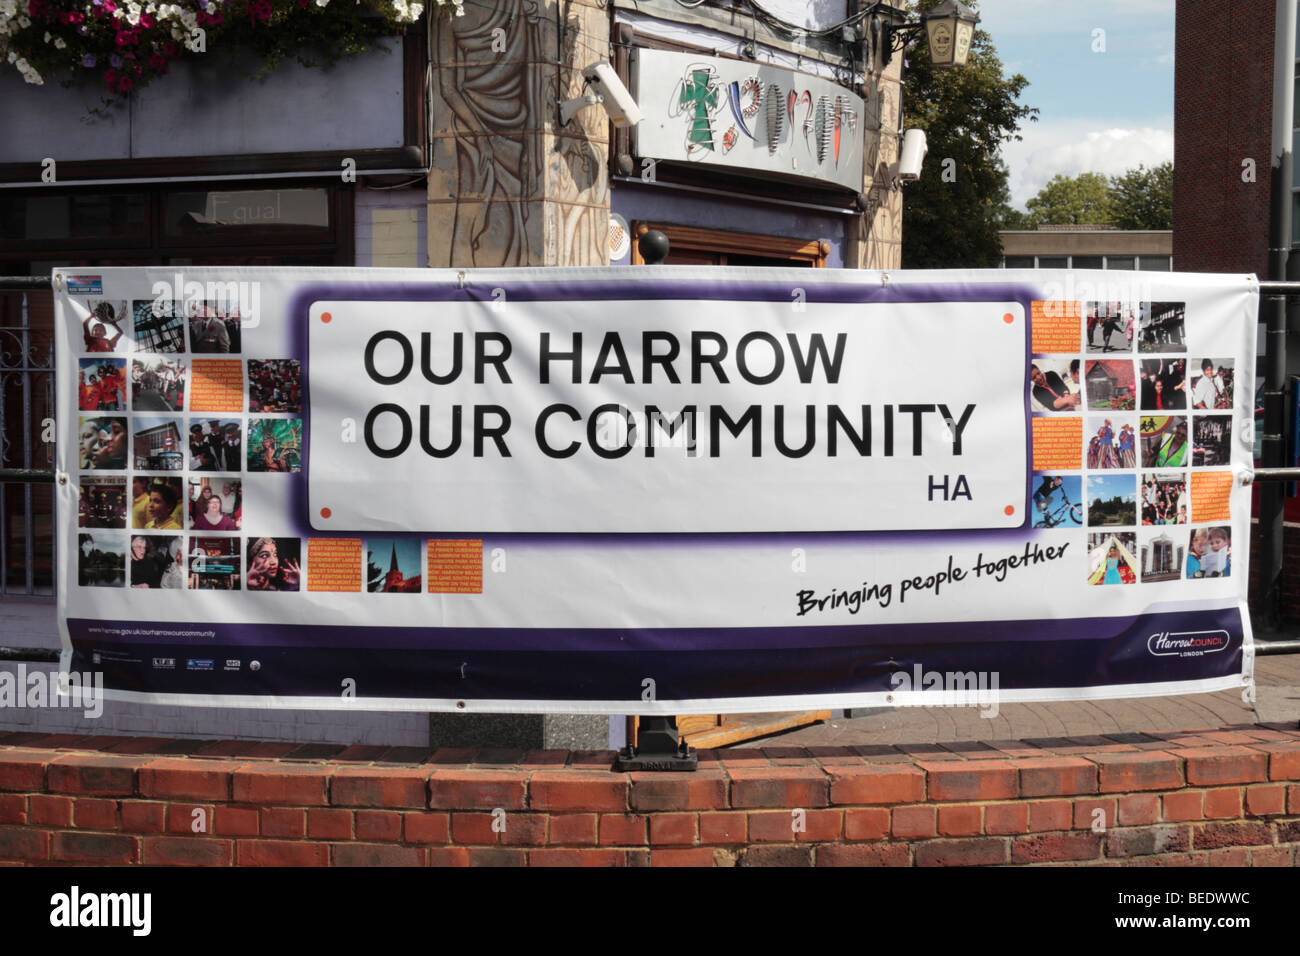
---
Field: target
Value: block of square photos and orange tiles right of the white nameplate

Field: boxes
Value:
[1030,300,1235,585]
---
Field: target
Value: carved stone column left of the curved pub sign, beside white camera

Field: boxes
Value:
[429,0,611,268]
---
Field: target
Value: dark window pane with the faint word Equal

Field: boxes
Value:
[166,189,330,238]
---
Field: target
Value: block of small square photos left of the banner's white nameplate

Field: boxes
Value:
[77,297,302,591]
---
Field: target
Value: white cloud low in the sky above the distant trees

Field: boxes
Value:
[1002,117,1174,208]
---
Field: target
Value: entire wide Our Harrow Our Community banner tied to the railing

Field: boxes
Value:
[55,267,1258,714]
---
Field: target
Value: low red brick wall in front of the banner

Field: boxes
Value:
[0,724,1300,866]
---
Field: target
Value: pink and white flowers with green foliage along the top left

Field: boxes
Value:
[0,0,464,98]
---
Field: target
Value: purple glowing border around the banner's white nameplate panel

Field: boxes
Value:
[286,280,1039,548]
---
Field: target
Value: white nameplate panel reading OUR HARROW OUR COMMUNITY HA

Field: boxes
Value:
[308,299,1027,533]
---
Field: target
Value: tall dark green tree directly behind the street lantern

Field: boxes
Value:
[894,0,1039,269]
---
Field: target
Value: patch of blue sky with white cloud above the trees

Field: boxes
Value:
[979,0,1180,209]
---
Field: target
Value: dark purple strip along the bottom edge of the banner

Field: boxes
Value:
[69,607,1244,713]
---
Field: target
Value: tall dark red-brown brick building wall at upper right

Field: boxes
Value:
[1174,0,1273,276]
